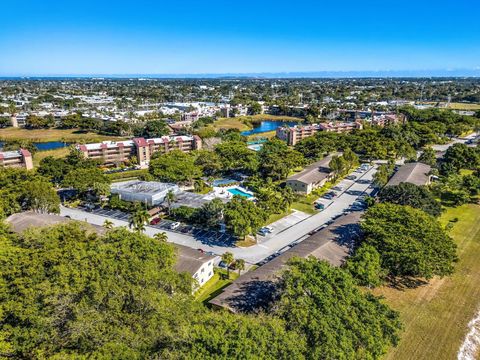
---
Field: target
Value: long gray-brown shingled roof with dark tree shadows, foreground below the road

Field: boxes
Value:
[209,212,362,312]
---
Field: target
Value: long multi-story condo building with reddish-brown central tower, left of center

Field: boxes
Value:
[77,135,202,166]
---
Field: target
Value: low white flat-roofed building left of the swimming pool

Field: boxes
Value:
[111,180,180,206]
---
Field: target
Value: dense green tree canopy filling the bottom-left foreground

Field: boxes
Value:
[0,223,308,360]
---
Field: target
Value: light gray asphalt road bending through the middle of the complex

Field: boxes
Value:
[60,168,376,264]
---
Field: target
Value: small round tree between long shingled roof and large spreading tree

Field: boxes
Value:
[345,244,385,288]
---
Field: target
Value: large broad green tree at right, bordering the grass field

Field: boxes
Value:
[361,203,457,279]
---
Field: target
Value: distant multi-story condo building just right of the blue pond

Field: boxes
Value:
[277,122,363,146]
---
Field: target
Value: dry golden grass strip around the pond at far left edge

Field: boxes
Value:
[0,127,120,142]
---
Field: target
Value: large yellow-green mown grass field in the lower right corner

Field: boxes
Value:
[374,204,480,360]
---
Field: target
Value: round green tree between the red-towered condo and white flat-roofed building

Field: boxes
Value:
[149,150,202,184]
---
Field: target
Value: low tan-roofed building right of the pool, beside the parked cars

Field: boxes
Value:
[286,155,332,194]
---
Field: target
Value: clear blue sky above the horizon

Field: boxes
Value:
[0,0,480,76]
